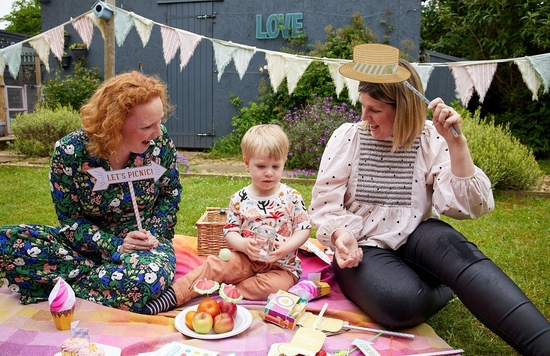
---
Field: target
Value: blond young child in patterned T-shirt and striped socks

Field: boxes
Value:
[141,124,311,315]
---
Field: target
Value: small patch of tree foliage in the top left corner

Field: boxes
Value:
[0,0,42,36]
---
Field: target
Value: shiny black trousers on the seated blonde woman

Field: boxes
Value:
[333,219,550,355]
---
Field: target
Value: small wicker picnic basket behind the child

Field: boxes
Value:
[196,207,229,256]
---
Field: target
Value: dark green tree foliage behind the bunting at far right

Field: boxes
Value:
[421,0,550,157]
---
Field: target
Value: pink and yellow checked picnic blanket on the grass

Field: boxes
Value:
[0,236,458,356]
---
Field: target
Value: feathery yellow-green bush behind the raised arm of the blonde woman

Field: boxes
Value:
[459,109,544,190]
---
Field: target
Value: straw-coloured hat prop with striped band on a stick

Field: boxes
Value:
[340,43,411,83]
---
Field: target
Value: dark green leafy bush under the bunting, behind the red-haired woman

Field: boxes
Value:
[42,61,101,110]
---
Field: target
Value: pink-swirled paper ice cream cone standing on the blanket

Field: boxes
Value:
[48,278,76,330]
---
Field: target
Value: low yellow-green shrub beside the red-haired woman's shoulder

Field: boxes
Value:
[12,107,82,157]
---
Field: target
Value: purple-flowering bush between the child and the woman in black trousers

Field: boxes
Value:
[280,94,361,170]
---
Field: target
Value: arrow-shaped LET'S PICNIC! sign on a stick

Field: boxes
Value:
[88,162,166,231]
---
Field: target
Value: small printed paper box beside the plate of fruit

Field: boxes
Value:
[264,290,307,330]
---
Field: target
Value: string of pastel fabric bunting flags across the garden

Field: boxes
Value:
[0,6,550,105]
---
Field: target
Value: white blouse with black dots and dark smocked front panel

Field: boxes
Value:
[309,120,495,249]
